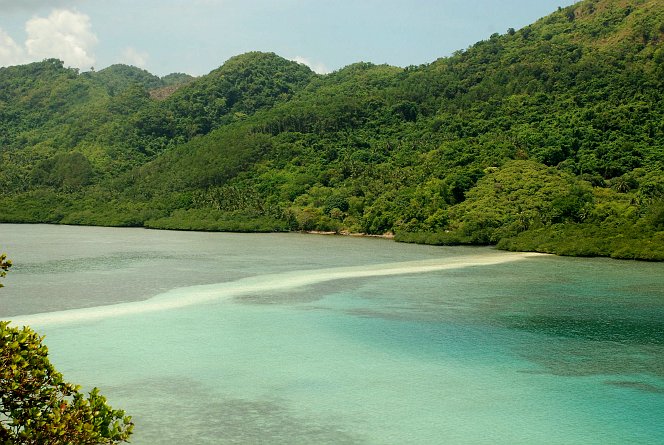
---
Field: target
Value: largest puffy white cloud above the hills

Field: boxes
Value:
[25,9,97,68]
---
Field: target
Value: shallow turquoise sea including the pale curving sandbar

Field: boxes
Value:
[0,225,664,444]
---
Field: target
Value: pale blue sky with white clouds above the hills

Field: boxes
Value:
[0,0,575,76]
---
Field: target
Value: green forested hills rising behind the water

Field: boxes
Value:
[0,0,664,260]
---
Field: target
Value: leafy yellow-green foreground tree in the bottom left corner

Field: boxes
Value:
[0,254,133,445]
